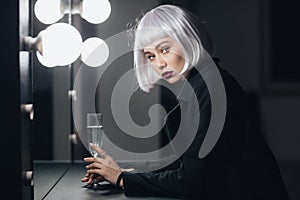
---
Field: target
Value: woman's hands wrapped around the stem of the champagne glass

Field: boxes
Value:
[81,144,123,186]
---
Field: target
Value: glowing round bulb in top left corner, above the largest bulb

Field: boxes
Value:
[34,0,64,24]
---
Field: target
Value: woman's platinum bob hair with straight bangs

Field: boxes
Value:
[133,5,211,92]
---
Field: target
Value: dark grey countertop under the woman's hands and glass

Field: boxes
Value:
[34,161,177,200]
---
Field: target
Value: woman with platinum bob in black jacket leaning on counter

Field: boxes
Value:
[82,5,288,200]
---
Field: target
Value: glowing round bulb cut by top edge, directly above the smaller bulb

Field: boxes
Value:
[81,0,111,24]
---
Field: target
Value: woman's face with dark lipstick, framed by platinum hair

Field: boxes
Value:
[144,37,185,83]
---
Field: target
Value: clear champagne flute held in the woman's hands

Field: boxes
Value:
[87,113,103,189]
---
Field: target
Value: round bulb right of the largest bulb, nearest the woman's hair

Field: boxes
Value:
[81,37,109,67]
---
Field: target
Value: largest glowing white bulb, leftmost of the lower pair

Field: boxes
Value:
[41,23,82,66]
